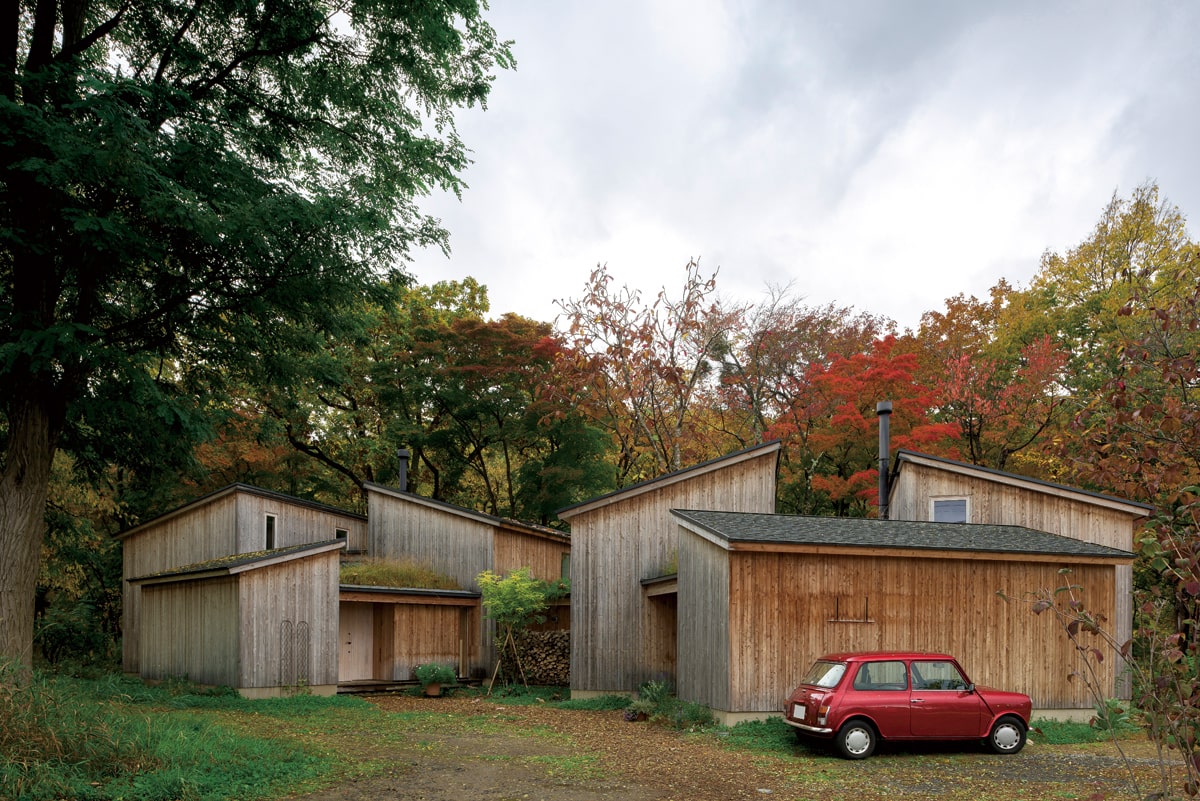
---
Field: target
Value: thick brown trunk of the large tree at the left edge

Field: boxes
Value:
[0,384,64,669]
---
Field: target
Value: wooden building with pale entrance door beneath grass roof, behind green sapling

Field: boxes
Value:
[360,482,571,681]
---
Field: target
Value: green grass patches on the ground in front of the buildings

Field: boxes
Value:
[0,674,1147,801]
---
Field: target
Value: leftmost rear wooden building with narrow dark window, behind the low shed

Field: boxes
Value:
[116,484,367,673]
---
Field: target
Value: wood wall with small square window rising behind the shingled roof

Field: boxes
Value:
[890,462,1136,690]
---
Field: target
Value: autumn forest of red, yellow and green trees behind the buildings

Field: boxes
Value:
[28,183,1200,661]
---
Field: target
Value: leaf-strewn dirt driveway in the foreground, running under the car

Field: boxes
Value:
[288,695,1171,801]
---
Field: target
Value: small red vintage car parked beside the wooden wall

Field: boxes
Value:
[784,651,1033,759]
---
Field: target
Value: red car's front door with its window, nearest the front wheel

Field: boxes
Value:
[908,660,985,739]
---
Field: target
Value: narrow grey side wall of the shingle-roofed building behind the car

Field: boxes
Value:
[677,531,731,710]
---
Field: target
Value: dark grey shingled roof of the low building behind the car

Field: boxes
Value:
[671,510,1133,562]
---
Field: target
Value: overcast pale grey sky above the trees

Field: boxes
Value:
[410,0,1200,329]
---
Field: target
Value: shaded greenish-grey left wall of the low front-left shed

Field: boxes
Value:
[137,576,239,687]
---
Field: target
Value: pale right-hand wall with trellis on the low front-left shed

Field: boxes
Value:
[235,550,341,688]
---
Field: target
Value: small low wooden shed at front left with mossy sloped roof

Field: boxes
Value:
[128,540,346,698]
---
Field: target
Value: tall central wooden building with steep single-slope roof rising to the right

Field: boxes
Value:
[558,442,780,697]
